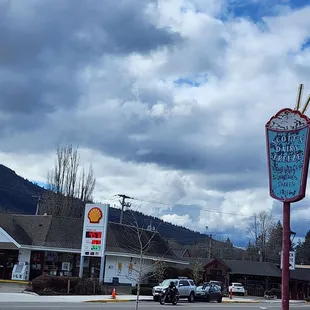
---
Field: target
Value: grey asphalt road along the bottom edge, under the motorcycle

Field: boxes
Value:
[0,302,310,310]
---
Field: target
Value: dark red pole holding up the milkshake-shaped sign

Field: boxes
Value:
[282,202,291,310]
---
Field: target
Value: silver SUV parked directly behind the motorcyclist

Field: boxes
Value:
[152,278,196,302]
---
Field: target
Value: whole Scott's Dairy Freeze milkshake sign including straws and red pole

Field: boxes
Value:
[265,85,310,310]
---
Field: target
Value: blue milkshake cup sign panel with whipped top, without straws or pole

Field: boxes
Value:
[266,109,310,202]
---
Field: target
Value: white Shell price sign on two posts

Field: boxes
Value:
[79,204,109,282]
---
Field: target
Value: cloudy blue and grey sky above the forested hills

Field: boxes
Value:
[0,0,310,244]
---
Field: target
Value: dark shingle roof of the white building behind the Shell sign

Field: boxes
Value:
[0,213,177,260]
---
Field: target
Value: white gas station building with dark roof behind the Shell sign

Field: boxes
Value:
[0,213,188,285]
